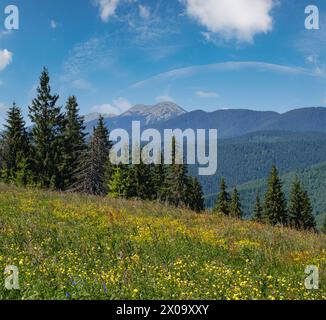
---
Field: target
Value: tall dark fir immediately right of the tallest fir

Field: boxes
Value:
[62,96,86,189]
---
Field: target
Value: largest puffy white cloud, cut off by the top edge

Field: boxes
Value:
[182,0,275,42]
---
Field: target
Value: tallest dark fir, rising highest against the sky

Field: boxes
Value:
[29,68,63,189]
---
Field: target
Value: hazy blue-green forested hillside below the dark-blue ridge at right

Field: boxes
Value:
[194,131,326,198]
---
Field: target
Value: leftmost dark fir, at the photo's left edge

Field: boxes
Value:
[1,103,32,185]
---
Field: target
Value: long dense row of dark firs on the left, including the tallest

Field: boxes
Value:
[0,68,205,212]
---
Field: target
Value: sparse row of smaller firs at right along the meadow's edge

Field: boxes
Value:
[214,165,318,231]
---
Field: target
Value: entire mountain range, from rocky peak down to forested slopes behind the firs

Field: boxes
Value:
[86,102,326,222]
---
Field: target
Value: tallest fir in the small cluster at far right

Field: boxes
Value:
[264,165,288,226]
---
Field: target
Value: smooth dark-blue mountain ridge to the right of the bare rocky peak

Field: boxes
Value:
[157,107,326,139]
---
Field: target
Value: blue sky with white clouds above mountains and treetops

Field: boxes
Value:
[0,0,326,124]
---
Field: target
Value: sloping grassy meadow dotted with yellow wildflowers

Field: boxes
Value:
[0,185,326,300]
